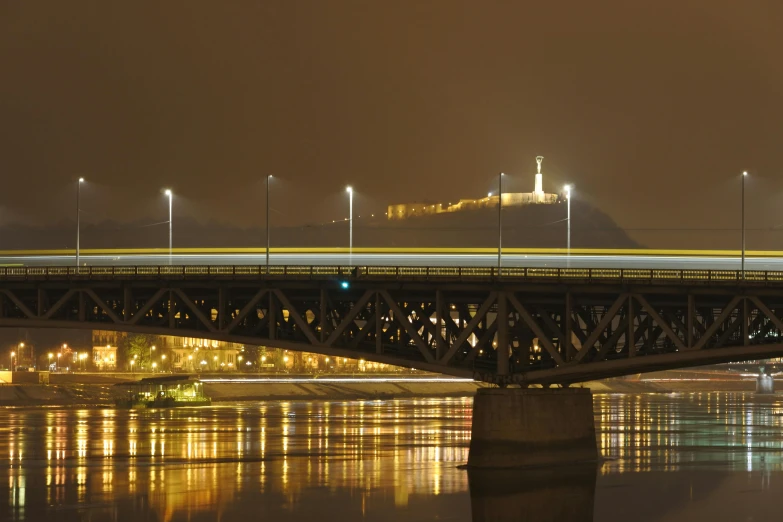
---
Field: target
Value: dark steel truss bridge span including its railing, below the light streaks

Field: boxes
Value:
[0,265,783,386]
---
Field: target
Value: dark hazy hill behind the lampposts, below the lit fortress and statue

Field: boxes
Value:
[0,201,639,250]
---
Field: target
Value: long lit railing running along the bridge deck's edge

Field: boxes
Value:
[0,265,783,284]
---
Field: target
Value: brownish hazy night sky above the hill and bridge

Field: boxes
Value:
[0,0,783,248]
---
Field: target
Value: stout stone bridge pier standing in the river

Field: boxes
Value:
[468,388,598,468]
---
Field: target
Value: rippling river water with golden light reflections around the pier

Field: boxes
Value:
[0,393,783,522]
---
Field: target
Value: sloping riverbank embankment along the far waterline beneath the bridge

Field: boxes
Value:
[0,370,772,407]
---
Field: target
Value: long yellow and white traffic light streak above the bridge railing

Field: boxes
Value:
[0,248,783,270]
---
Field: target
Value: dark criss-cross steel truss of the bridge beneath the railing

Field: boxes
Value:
[0,280,783,385]
